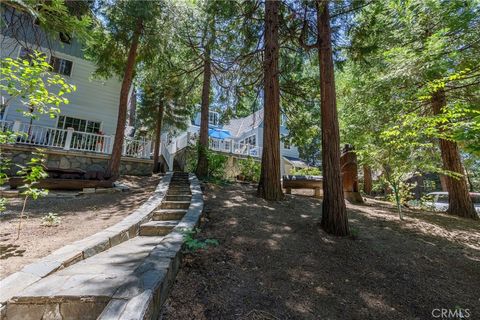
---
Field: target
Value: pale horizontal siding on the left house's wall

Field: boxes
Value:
[0,35,121,135]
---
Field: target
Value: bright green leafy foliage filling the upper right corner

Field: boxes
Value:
[337,0,480,185]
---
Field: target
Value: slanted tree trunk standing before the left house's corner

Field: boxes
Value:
[106,19,142,180]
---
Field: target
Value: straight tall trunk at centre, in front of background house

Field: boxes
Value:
[257,0,283,200]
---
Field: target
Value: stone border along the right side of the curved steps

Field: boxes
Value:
[97,174,204,320]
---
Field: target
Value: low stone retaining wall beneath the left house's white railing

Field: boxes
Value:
[0,145,153,176]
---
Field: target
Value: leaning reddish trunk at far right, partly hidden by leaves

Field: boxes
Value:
[431,89,478,219]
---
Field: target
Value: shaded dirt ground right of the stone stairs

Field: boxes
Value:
[160,184,480,320]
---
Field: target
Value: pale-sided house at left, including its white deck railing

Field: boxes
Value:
[0,8,151,158]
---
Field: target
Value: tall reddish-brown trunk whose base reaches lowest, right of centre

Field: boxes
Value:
[316,0,349,236]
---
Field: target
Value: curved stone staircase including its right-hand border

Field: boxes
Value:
[1,172,203,320]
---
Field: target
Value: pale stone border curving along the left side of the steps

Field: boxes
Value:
[0,172,172,317]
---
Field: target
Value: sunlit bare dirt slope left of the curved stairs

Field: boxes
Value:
[0,176,160,279]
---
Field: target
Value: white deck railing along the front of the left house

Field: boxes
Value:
[0,120,152,159]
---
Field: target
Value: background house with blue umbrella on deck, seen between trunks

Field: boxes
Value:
[178,109,307,174]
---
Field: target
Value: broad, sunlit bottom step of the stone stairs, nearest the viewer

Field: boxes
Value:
[6,237,168,320]
